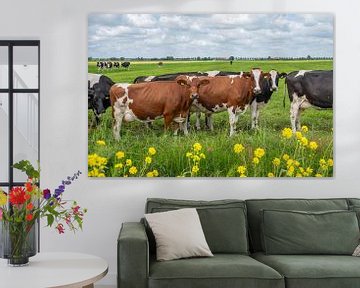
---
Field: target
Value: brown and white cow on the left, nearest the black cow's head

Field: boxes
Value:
[110,75,209,140]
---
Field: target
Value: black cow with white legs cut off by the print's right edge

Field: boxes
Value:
[284,70,333,133]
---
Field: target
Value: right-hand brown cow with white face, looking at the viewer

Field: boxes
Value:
[193,68,264,136]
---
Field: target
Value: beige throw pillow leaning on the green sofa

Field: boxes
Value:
[145,208,213,261]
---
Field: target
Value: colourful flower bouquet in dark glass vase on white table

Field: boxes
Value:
[0,160,86,265]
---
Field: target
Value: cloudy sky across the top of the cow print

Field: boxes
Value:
[88,14,334,58]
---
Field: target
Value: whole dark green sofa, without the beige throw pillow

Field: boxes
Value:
[117,198,360,288]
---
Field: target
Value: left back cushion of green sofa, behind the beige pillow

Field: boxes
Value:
[146,198,249,255]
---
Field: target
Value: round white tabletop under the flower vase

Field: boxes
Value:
[0,252,108,288]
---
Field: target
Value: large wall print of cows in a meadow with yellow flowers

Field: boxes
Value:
[87,13,334,177]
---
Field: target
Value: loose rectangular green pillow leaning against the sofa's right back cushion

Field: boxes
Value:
[262,210,360,255]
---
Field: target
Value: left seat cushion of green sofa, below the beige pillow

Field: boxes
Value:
[149,254,285,288]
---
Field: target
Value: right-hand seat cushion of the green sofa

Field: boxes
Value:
[251,252,360,288]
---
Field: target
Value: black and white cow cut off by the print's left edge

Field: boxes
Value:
[88,73,115,126]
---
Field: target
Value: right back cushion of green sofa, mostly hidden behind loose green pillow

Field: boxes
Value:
[246,199,348,252]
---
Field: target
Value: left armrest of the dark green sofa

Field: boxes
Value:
[117,222,149,288]
